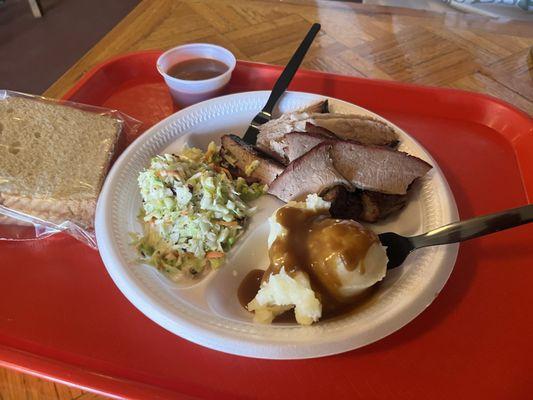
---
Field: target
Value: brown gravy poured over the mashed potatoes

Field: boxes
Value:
[239,207,377,322]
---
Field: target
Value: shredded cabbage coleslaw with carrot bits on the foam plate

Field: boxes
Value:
[133,142,266,280]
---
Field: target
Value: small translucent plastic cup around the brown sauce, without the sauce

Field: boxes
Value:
[157,43,237,107]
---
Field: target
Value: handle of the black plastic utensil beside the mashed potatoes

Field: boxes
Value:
[410,204,533,249]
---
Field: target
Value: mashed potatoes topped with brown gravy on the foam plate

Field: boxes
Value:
[248,194,387,325]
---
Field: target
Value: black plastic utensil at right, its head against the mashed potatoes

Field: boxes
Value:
[379,204,533,269]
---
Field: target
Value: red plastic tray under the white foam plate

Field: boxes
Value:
[0,51,533,400]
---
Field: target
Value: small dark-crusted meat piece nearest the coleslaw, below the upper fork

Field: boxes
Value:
[221,135,283,185]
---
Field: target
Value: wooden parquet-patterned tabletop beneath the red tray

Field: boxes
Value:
[4,0,533,400]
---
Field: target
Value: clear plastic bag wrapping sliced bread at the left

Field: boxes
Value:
[0,90,141,248]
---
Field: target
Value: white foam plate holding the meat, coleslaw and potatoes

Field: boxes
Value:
[96,91,458,359]
